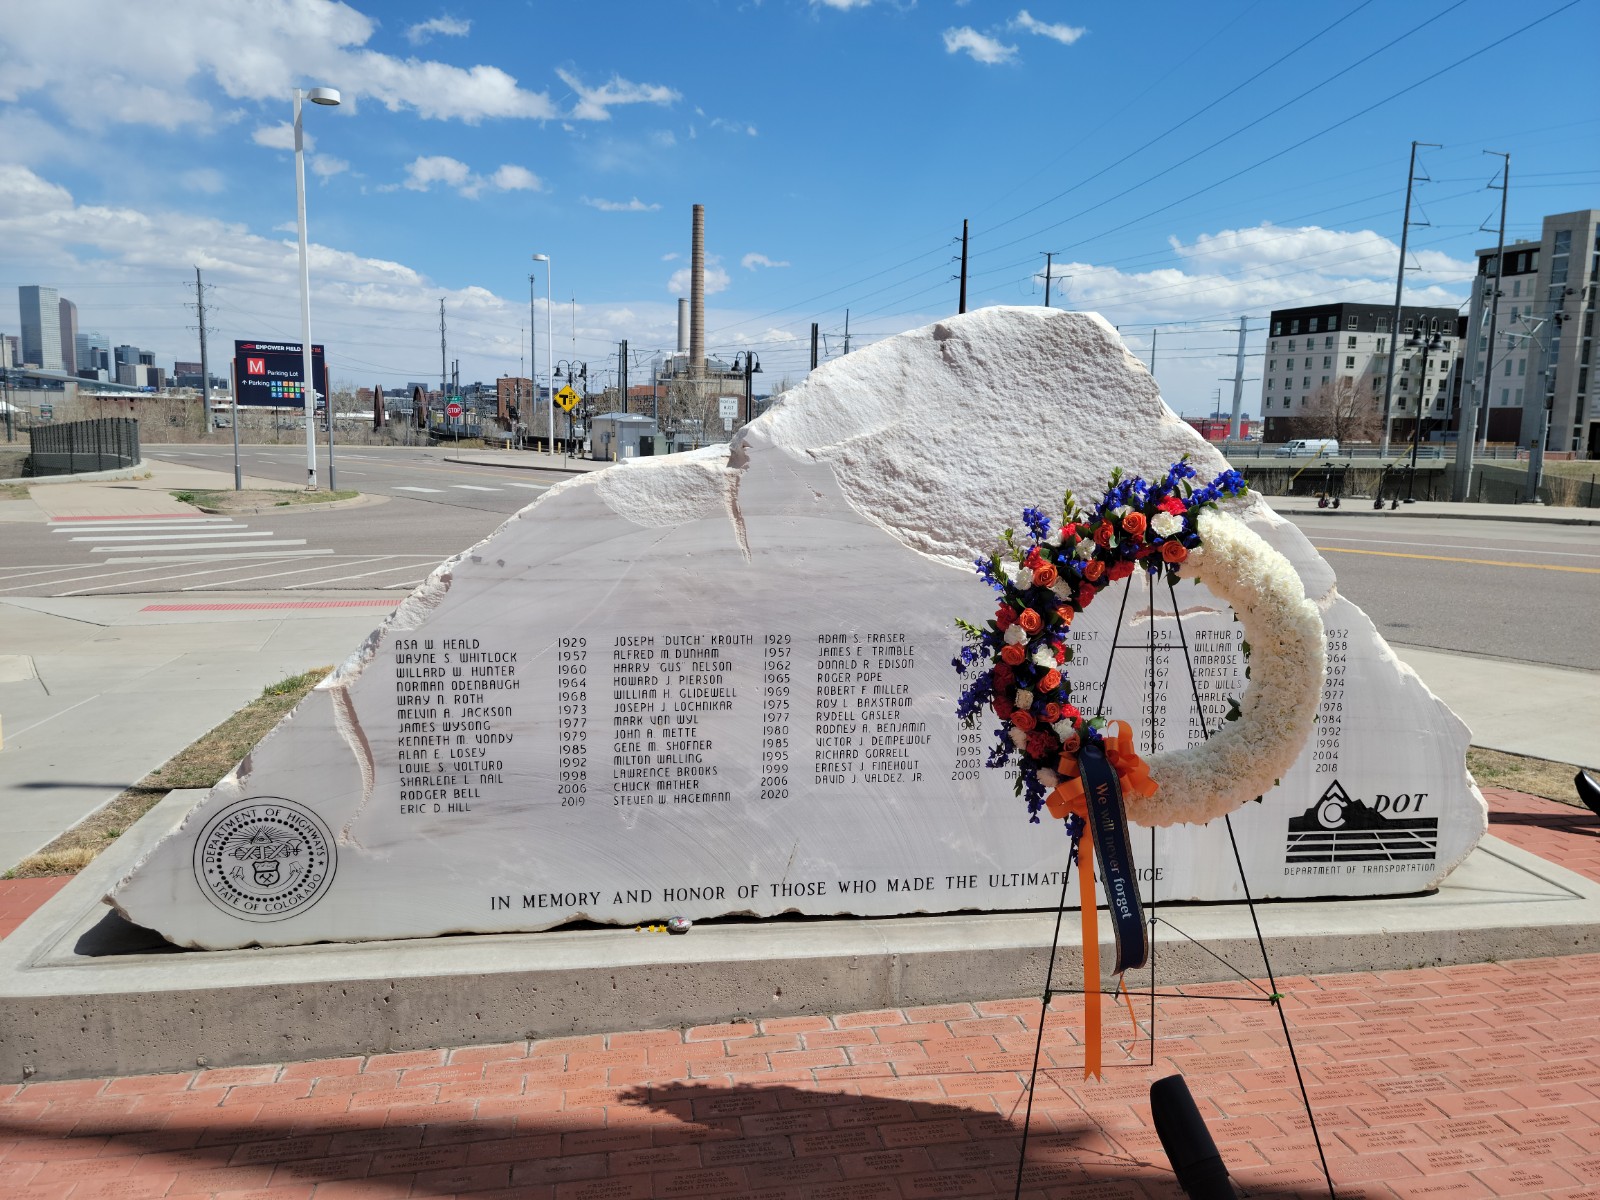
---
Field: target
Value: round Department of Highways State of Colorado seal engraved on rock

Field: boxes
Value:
[194,795,338,922]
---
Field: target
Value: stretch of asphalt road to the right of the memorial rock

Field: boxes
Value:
[1296,514,1600,670]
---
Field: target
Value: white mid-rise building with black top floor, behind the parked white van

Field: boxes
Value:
[1261,304,1464,442]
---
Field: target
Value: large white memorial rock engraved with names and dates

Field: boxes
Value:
[107,309,1485,947]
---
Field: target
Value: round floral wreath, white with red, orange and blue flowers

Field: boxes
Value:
[954,458,1326,837]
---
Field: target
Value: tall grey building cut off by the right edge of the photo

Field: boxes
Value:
[1467,208,1600,458]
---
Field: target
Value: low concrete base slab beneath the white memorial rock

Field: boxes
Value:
[0,792,1600,1082]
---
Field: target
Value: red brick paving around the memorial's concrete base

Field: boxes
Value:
[0,792,1600,1200]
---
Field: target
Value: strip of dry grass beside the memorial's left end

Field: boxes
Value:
[5,667,333,878]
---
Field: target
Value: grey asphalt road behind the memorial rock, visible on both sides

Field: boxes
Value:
[0,445,1600,670]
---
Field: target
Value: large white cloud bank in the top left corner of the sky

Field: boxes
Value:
[0,0,557,130]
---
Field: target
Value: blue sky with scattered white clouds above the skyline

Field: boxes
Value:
[0,0,1600,413]
